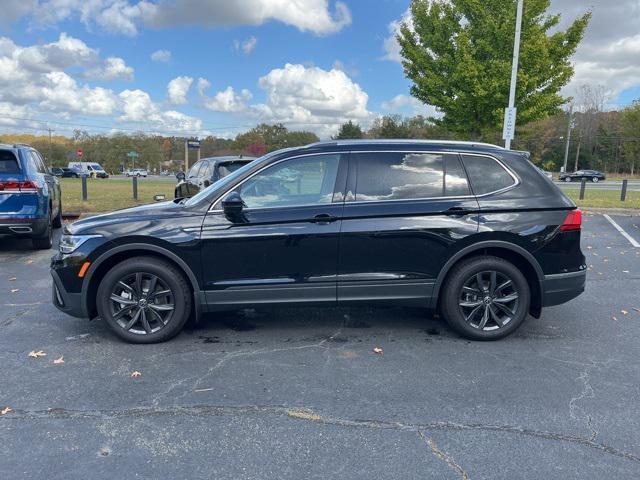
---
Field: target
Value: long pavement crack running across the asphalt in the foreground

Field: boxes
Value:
[0,405,640,463]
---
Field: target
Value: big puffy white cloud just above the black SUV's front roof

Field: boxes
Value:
[252,64,372,136]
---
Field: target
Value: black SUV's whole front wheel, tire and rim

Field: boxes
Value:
[96,257,192,343]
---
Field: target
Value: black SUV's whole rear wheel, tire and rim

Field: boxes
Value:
[440,256,531,340]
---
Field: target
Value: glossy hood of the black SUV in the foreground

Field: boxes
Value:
[65,201,200,235]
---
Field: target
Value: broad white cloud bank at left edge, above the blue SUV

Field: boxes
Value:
[0,34,202,134]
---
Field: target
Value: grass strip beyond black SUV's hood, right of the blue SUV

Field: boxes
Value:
[60,178,175,214]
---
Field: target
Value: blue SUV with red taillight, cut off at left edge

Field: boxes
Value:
[0,144,62,249]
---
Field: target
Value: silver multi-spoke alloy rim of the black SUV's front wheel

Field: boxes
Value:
[109,272,175,335]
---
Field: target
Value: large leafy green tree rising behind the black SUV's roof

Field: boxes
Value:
[397,0,591,139]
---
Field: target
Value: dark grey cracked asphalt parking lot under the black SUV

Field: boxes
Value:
[0,214,640,480]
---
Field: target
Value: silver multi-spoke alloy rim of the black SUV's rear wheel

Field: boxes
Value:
[458,270,519,331]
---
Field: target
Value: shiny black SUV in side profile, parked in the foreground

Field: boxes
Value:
[51,140,586,343]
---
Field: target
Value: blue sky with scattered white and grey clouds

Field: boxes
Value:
[0,0,640,138]
